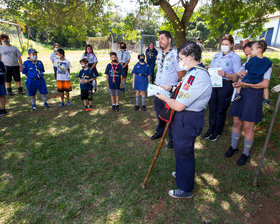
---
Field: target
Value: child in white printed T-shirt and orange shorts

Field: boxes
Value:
[55,49,72,107]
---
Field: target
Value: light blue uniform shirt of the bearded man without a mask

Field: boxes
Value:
[156,49,183,86]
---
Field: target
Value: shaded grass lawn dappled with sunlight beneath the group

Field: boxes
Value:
[0,49,280,224]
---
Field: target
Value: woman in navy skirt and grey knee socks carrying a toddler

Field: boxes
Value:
[225,41,272,166]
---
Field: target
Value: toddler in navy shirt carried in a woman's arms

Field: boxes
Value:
[234,40,272,105]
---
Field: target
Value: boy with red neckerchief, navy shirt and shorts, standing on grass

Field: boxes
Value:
[105,52,123,111]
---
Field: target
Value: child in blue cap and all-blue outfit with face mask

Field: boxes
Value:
[22,49,49,110]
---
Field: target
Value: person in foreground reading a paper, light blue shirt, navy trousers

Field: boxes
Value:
[157,41,212,198]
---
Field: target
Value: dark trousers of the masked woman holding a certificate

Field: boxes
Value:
[209,80,233,135]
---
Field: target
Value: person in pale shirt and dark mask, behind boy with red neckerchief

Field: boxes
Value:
[117,42,131,92]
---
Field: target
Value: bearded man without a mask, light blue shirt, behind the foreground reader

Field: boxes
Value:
[151,31,185,148]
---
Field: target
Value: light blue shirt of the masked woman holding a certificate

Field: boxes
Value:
[210,51,241,80]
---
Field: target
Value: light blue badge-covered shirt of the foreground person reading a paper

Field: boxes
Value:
[176,67,212,112]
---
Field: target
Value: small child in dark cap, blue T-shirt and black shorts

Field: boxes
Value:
[78,58,96,111]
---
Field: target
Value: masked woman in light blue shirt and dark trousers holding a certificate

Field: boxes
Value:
[203,35,241,141]
